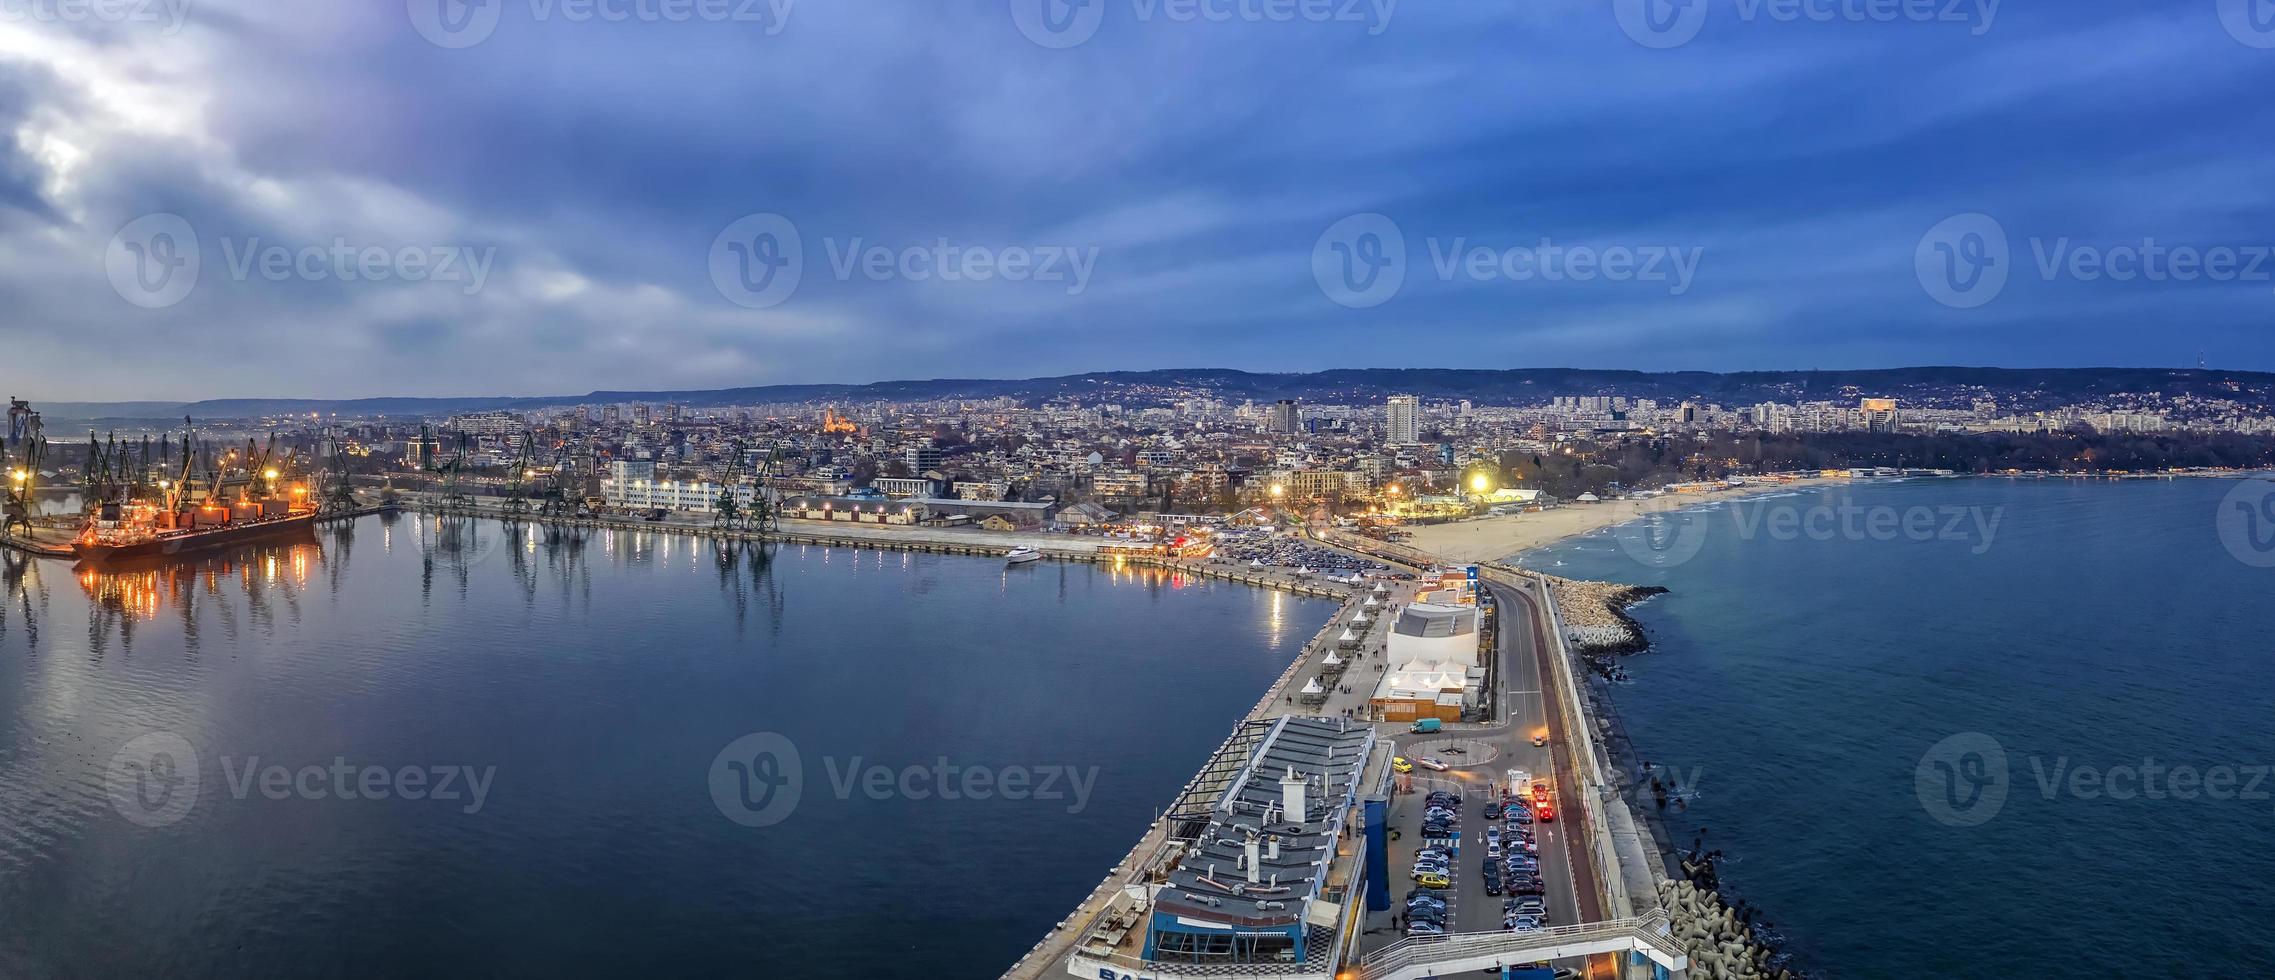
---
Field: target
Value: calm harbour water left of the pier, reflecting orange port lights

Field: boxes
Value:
[0,516,1331,978]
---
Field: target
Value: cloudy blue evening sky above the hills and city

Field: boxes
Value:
[0,0,2275,400]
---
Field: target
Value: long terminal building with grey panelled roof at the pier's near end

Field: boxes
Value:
[1067,716,1392,980]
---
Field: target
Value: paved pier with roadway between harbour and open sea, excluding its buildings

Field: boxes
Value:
[1003,530,1690,980]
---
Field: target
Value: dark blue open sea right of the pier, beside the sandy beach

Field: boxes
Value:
[1527,480,2275,978]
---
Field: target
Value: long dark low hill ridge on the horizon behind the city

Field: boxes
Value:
[41,366,2275,421]
